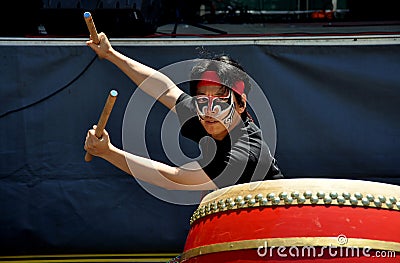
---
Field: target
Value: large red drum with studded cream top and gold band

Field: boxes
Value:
[181,179,400,263]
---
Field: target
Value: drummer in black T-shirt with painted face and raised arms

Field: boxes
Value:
[84,33,283,190]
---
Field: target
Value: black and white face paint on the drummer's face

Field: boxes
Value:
[195,90,235,127]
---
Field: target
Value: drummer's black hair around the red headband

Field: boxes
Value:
[189,55,252,120]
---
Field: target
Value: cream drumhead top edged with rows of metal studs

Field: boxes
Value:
[190,179,400,224]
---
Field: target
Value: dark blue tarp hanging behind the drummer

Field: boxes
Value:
[0,40,400,255]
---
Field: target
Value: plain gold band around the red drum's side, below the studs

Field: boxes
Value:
[181,236,400,262]
